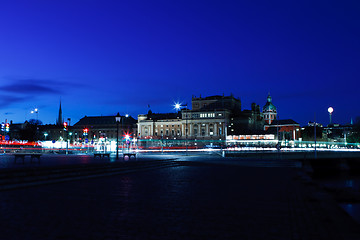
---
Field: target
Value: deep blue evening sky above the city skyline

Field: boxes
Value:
[0,0,360,125]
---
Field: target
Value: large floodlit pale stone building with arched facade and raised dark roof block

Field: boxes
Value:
[138,95,263,140]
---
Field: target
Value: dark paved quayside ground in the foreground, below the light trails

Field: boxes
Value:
[0,153,360,239]
